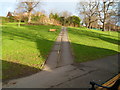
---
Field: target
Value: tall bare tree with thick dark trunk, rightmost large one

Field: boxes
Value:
[98,0,115,31]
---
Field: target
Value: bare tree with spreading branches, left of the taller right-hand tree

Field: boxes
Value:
[78,1,98,28]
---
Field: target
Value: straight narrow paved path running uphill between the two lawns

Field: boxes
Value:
[44,27,73,70]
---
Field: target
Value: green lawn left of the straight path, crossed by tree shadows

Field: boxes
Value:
[2,23,61,81]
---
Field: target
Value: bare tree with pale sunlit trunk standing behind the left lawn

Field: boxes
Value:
[18,0,40,23]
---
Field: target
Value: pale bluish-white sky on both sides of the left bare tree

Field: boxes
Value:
[0,0,78,16]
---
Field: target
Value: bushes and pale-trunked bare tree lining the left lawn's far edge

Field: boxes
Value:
[4,0,81,27]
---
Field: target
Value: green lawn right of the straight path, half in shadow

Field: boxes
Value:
[68,27,120,62]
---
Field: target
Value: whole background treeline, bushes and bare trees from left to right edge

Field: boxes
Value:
[3,0,120,31]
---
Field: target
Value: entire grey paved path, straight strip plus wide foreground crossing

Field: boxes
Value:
[3,28,118,89]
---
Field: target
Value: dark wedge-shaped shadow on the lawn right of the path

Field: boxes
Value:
[71,43,119,62]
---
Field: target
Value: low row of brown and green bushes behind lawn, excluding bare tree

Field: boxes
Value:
[6,11,81,27]
